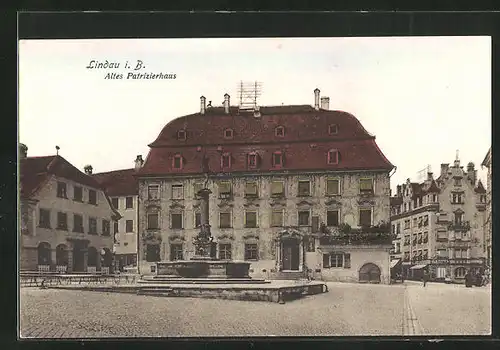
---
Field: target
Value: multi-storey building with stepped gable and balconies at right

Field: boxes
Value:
[391,159,486,281]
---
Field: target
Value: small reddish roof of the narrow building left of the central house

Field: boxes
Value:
[92,168,139,197]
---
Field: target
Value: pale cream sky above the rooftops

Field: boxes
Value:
[18,36,491,193]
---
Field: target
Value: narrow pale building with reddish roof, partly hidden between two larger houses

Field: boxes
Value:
[93,155,144,270]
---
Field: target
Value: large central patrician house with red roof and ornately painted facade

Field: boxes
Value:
[138,90,394,282]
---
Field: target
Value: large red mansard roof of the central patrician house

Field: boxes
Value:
[138,105,394,176]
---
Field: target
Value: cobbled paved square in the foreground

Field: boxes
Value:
[20,282,491,338]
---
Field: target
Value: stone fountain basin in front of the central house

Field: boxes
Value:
[156,260,250,278]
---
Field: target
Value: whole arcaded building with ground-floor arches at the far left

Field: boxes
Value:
[19,145,119,272]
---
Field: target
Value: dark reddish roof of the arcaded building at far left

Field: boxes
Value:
[19,155,101,197]
